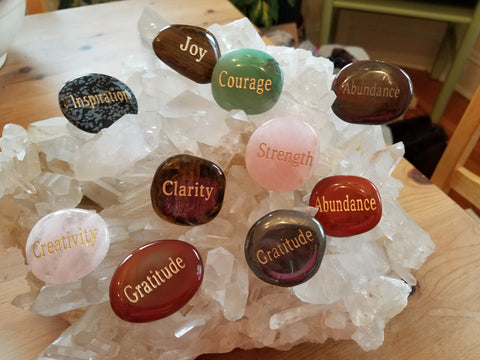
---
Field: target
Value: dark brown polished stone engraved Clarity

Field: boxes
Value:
[151,155,225,225]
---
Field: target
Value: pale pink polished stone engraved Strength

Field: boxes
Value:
[245,117,319,192]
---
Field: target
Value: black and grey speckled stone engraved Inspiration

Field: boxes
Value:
[58,74,138,133]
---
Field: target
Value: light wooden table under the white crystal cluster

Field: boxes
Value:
[0,0,480,360]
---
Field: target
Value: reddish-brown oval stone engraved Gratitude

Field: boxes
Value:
[109,240,203,323]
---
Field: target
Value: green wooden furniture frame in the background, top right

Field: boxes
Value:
[320,0,480,122]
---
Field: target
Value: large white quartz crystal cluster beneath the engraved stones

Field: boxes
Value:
[0,12,434,360]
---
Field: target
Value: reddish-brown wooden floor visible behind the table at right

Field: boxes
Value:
[404,69,480,214]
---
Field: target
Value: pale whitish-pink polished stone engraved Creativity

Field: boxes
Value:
[25,209,110,284]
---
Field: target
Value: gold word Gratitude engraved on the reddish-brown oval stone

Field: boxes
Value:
[123,257,186,303]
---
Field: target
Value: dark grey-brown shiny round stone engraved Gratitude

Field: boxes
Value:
[245,210,325,286]
